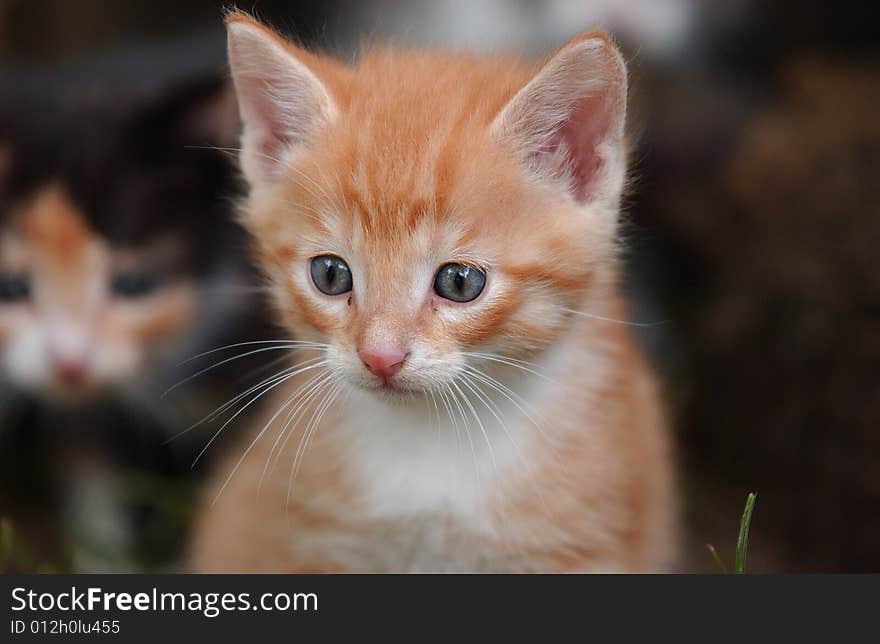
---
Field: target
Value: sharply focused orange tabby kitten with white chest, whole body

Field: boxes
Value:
[193,14,675,572]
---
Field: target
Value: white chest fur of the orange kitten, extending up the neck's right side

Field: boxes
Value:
[337,330,589,534]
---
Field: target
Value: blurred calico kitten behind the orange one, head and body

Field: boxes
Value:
[0,74,264,568]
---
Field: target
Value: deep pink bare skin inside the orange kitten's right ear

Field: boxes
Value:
[533,95,611,202]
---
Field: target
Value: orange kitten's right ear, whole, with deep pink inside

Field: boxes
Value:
[492,33,626,203]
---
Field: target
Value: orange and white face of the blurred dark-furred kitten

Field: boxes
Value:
[0,185,195,399]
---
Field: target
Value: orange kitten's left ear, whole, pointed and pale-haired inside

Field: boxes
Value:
[226,13,336,182]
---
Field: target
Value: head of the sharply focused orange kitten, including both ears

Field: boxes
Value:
[229,16,625,399]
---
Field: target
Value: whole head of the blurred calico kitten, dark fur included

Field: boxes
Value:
[0,73,248,403]
